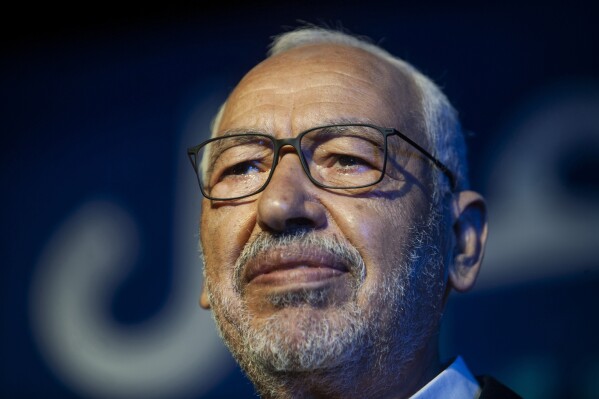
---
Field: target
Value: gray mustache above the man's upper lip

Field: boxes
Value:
[234,229,366,292]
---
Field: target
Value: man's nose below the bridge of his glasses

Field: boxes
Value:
[257,152,327,232]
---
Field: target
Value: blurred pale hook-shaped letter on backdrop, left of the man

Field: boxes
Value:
[30,97,234,398]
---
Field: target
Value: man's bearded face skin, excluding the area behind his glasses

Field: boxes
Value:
[201,45,447,390]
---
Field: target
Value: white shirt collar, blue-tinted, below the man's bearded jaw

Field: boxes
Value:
[410,356,480,399]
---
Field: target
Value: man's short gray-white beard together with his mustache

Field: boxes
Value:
[207,205,445,396]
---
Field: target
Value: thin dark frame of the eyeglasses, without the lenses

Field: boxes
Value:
[187,123,457,201]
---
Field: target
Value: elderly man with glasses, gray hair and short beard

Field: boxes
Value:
[189,27,517,398]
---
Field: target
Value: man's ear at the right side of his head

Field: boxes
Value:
[449,191,487,292]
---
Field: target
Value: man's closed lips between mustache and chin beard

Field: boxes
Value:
[240,245,349,287]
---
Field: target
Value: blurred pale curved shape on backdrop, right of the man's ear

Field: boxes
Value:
[477,84,599,288]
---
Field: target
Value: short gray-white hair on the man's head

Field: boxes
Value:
[211,26,469,196]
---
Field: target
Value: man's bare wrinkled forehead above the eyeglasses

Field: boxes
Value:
[218,44,424,140]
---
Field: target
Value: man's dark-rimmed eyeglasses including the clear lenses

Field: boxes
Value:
[187,124,456,201]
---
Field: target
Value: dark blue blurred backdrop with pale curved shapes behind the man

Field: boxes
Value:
[0,1,599,399]
